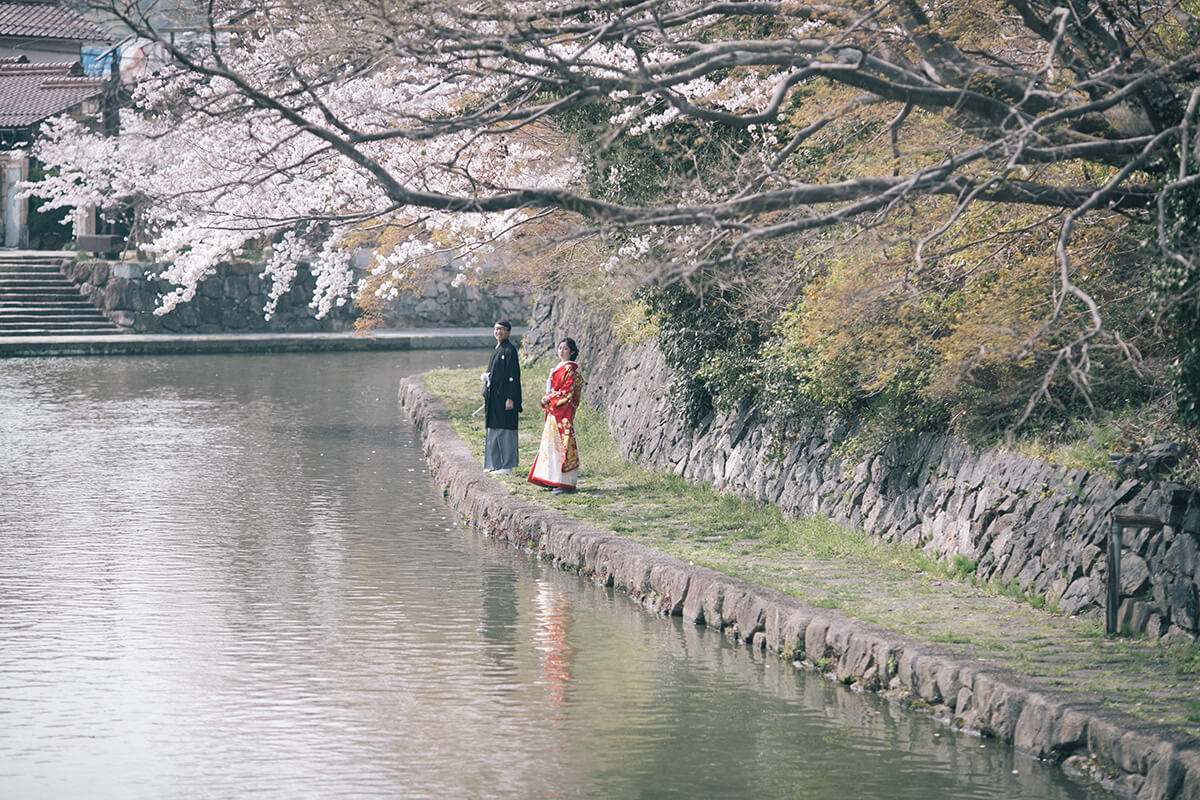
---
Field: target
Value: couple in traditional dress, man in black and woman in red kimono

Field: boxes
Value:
[482,320,582,492]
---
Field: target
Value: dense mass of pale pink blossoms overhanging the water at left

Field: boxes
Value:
[28,25,578,315]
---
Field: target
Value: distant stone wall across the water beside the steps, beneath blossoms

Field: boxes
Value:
[62,260,529,333]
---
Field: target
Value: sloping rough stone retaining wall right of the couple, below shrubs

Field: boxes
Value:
[523,295,1200,640]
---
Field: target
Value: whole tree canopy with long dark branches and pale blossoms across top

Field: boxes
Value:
[28,0,1200,422]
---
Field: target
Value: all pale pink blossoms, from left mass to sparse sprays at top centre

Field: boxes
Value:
[28,2,811,315]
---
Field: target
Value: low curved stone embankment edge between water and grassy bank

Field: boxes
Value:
[398,377,1200,800]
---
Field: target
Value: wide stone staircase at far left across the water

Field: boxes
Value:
[0,253,121,337]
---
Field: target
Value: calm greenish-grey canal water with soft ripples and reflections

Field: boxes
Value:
[0,351,1102,800]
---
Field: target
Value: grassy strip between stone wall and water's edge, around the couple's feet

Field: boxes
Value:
[424,365,1200,739]
